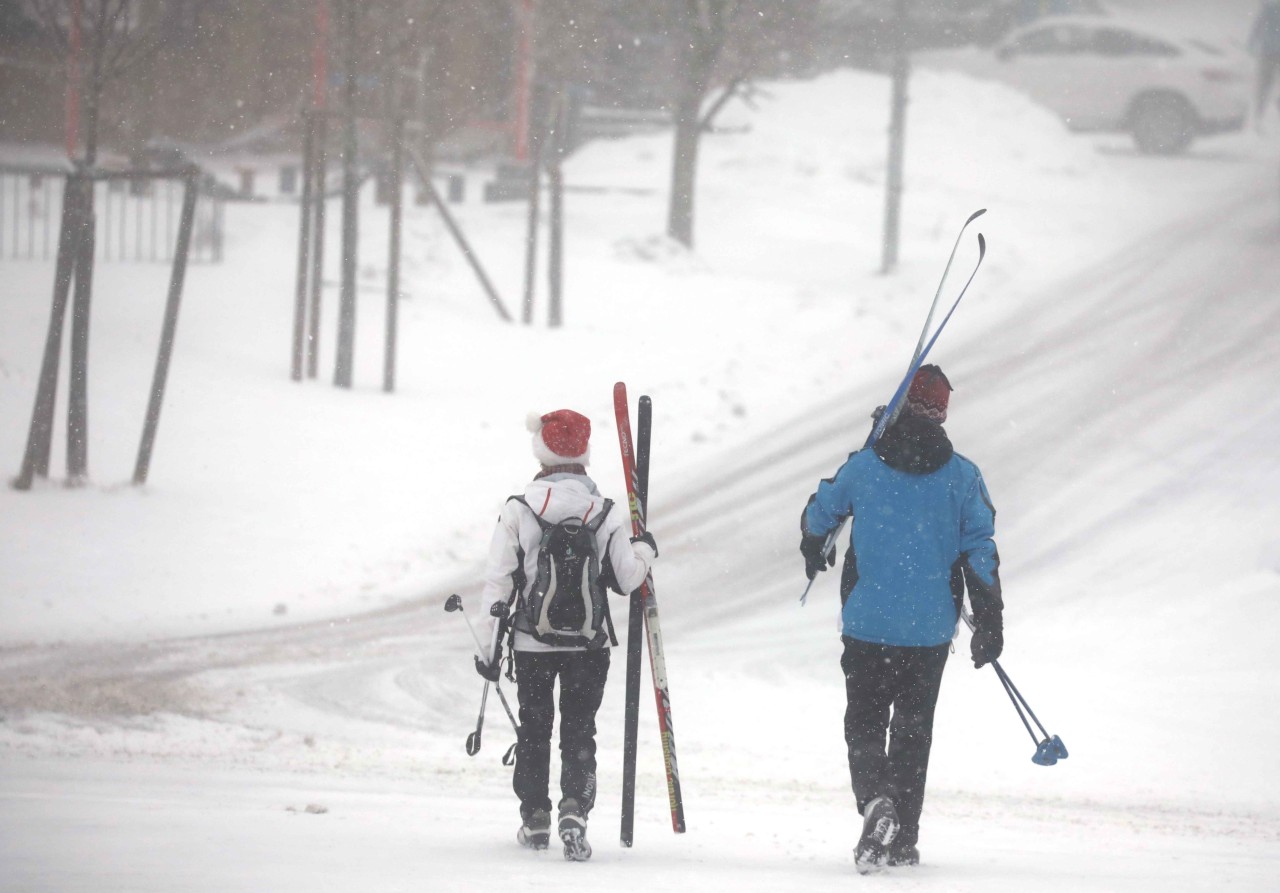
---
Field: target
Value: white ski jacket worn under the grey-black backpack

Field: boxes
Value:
[480,472,657,661]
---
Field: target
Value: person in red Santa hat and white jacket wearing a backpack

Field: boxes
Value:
[477,409,658,861]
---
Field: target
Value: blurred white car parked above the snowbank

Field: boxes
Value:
[916,15,1249,154]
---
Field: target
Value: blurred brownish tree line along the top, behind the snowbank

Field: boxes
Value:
[0,0,1018,246]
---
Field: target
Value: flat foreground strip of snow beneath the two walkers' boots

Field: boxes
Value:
[0,760,1277,893]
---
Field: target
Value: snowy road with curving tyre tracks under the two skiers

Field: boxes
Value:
[0,151,1280,893]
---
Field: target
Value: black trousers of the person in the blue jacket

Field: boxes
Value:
[840,636,951,844]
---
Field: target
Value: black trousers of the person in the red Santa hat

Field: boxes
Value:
[512,649,609,819]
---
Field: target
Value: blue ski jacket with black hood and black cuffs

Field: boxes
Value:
[801,413,1004,646]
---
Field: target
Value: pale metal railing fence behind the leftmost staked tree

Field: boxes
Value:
[0,165,225,264]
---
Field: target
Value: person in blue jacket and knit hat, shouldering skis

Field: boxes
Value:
[800,365,1004,874]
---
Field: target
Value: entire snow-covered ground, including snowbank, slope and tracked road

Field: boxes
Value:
[0,59,1280,892]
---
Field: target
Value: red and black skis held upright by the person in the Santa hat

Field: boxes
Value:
[613,381,685,847]
